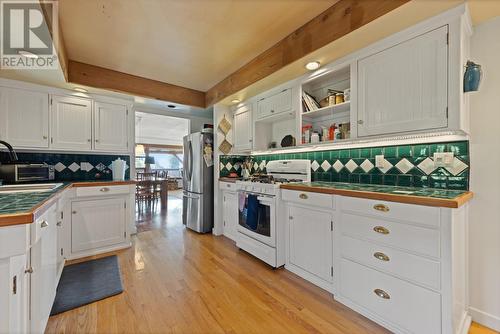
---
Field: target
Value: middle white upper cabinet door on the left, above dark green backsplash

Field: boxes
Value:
[51,96,92,151]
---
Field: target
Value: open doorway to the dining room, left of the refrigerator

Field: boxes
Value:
[135,111,190,233]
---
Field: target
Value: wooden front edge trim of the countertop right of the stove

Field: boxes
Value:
[281,184,473,209]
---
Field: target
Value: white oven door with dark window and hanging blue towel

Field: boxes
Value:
[238,192,276,247]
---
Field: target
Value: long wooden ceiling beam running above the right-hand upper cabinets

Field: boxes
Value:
[205,0,409,106]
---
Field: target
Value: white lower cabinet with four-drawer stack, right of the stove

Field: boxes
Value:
[282,190,470,334]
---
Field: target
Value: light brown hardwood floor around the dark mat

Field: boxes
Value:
[46,196,496,334]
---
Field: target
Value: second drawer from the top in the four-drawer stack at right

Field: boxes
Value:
[341,213,440,258]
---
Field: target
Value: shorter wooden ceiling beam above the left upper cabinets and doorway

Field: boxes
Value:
[68,59,205,108]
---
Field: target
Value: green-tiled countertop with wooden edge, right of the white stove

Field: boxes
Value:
[281,182,473,208]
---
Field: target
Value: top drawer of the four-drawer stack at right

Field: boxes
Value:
[342,197,439,228]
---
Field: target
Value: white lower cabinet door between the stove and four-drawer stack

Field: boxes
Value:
[288,205,333,282]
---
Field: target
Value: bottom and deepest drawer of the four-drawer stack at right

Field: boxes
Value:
[340,259,441,334]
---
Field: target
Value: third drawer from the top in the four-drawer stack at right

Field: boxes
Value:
[340,236,441,290]
